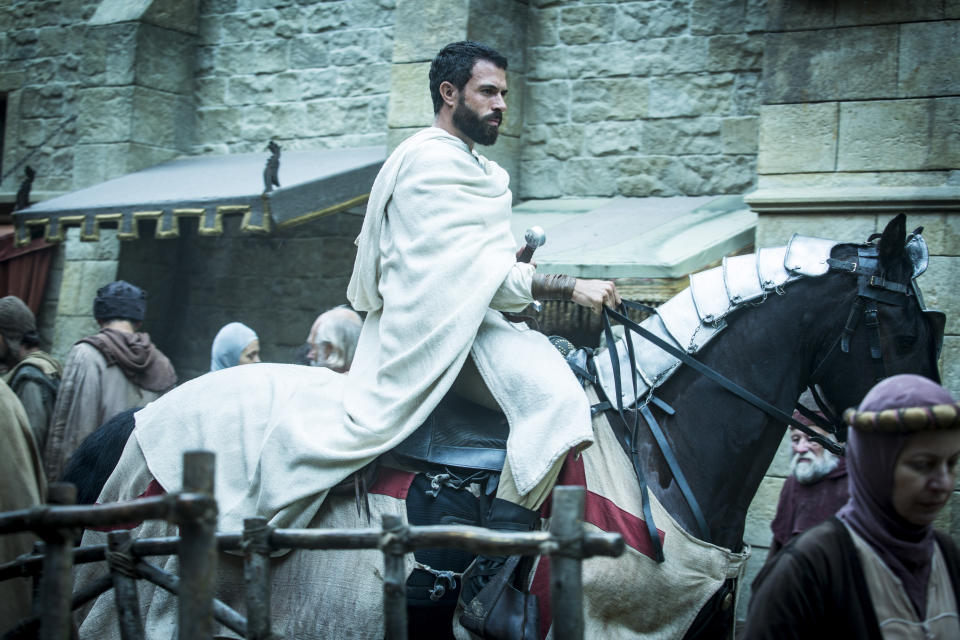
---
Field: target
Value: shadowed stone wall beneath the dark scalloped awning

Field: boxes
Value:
[115,209,363,382]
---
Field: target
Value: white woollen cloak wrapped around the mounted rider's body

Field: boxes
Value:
[343,127,593,495]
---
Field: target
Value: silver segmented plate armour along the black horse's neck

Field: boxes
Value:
[594,235,888,407]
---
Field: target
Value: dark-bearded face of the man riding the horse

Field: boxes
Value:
[453,60,507,145]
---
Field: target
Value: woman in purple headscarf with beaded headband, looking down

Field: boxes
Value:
[744,375,960,640]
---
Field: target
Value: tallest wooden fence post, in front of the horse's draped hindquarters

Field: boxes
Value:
[177,451,217,640]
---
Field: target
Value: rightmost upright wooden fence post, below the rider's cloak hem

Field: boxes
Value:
[550,486,586,640]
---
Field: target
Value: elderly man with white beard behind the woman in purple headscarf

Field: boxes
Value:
[767,412,849,559]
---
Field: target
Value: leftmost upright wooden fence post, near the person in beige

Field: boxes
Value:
[40,482,77,640]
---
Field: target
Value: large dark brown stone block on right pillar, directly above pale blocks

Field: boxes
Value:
[763,26,898,104]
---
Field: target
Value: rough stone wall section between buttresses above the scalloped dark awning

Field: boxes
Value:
[194,0,394,153]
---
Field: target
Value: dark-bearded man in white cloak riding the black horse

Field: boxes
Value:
[344,42,619,633]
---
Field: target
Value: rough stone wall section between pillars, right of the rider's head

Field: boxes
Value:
[519,0,765,199]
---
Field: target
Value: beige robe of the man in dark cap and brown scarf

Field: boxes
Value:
[43,342,160,482]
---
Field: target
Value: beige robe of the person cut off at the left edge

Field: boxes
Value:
[0,380,47,631]
